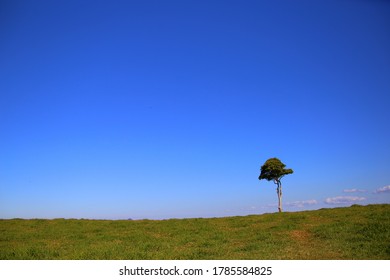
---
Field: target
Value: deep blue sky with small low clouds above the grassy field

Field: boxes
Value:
[0,0,390,219]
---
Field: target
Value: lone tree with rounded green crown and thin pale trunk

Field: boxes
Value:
[259,158,294,212]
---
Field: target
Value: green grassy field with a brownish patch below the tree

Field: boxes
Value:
[0,204,390,260]
